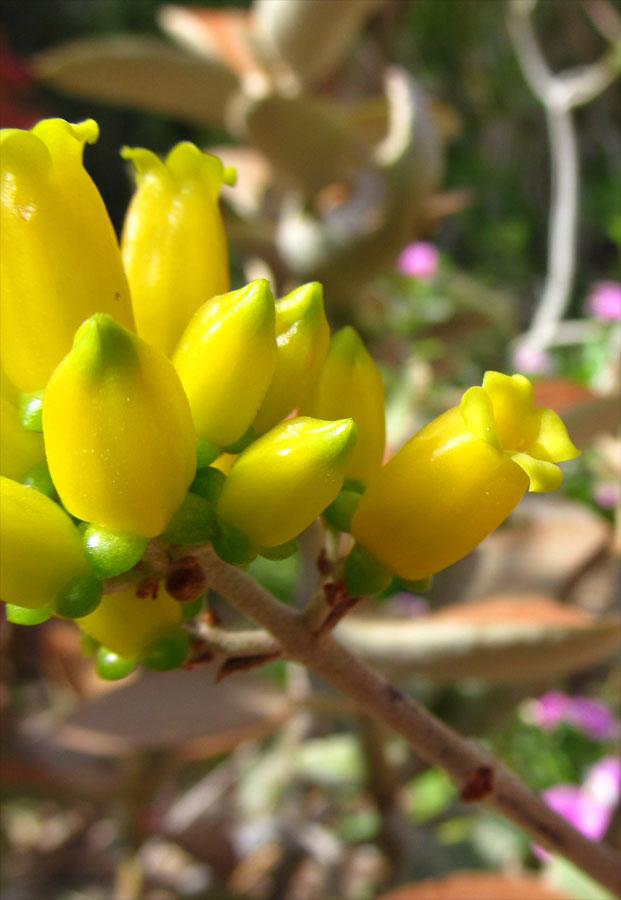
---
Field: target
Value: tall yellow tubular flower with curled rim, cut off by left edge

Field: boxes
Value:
[0,119,133,391]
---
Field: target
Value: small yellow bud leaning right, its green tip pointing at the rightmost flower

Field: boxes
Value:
[218,418,356,547]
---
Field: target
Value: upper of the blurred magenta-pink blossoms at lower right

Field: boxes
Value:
[527,691,619,741]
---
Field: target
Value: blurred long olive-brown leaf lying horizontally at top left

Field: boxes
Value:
[32,35,237,126]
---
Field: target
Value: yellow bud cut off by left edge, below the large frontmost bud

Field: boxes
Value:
[0,477,88,609]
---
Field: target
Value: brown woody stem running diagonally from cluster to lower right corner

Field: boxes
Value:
[198,547,619,892]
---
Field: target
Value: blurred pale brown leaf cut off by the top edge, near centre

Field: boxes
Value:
[253,0,386,85]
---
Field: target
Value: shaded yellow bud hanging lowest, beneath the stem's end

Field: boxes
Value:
[78,584,182,657]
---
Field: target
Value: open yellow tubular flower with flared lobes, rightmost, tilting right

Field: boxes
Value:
[352,372,579,580]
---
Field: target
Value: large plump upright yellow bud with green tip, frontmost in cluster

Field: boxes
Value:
[43,314,196,537]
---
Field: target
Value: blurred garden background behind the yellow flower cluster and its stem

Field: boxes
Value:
[0,0,621,900]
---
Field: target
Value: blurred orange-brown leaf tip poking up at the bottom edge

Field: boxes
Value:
[377,872,569,900]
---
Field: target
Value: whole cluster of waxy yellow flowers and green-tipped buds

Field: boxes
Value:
[0,119,577,677]
